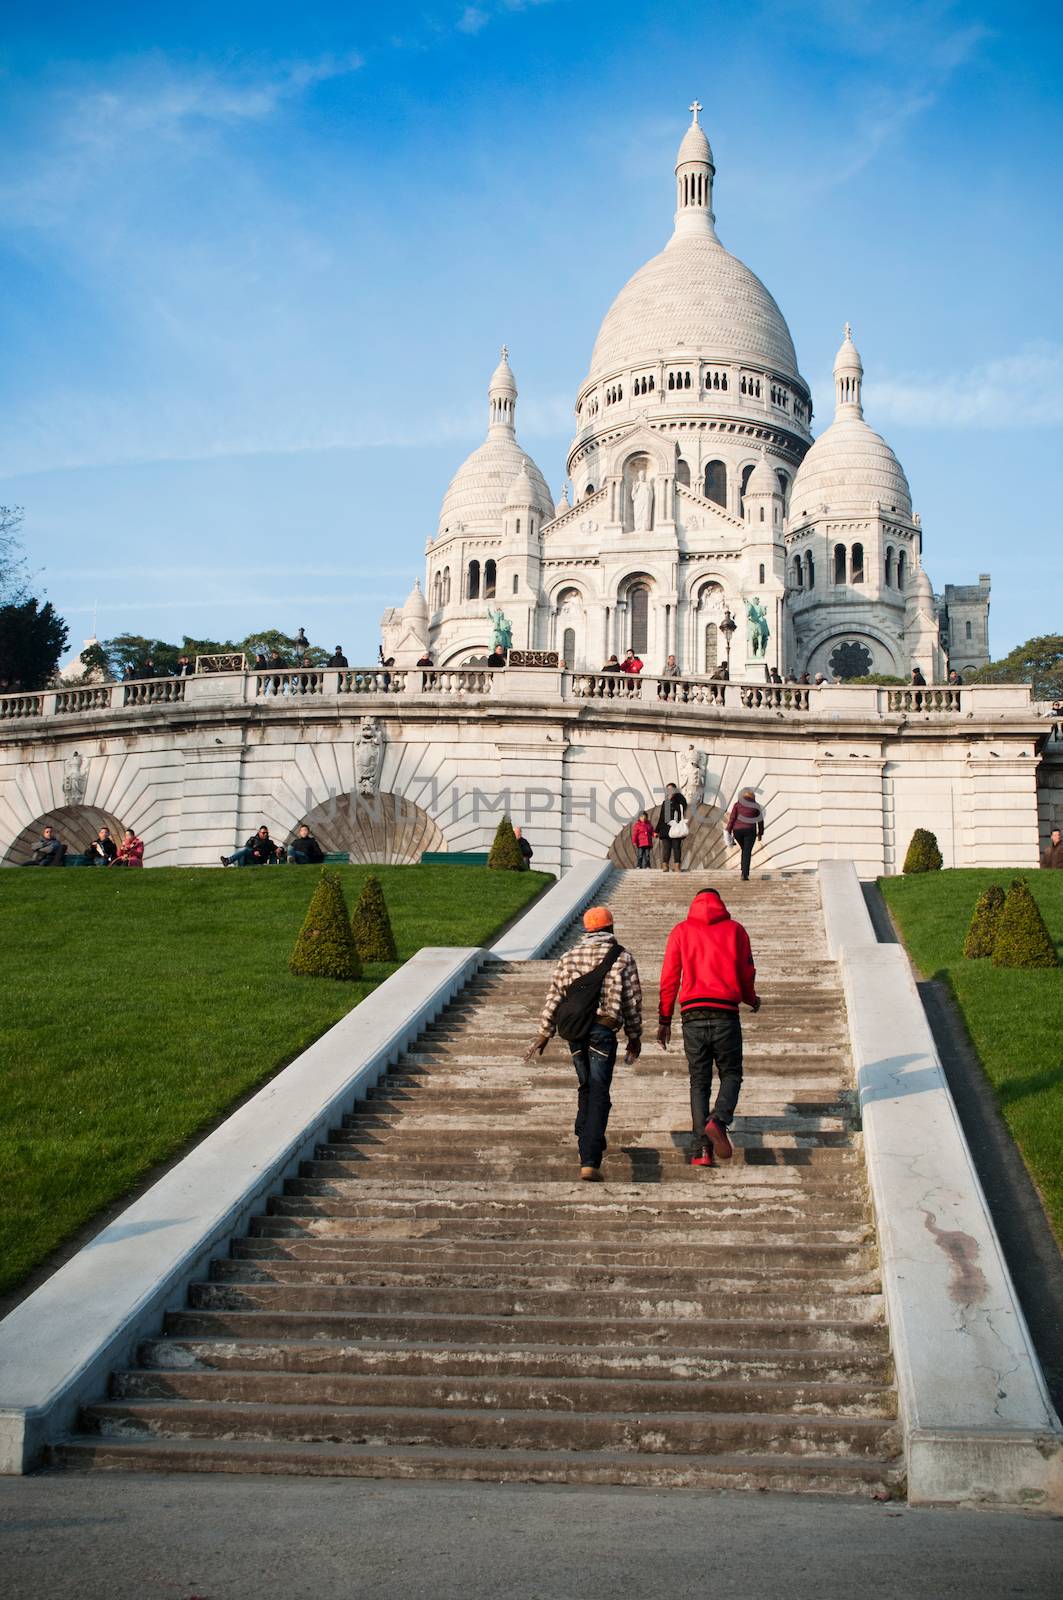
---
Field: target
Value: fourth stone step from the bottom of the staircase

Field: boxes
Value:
[138,1338,893,1388]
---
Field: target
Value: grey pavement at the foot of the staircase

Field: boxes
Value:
[0,1474,1063,1600]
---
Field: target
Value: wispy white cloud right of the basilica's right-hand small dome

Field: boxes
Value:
[816,339,1063,429]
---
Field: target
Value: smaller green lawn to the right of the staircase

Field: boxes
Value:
[879,869,1063,1240]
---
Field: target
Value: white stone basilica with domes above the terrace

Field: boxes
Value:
[383,101,989,682]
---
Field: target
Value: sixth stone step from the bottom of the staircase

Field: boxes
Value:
[189,1282,882,1322]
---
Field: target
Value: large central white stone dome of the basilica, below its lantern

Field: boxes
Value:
[586,233,804,386]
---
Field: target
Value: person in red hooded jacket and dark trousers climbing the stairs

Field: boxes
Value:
[656,890,760,1166]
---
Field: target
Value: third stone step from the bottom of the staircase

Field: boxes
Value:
[110,1368,897,1419]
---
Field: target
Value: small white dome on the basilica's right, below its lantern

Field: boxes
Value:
[789,416,911,523]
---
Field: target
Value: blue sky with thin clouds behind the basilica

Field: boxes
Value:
[0,0,1063,661]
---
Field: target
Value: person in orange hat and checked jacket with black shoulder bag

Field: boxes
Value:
[523,906,642,1182]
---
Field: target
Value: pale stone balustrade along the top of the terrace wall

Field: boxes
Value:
[0,666,1030,741]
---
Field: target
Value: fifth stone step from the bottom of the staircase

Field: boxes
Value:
[165,1302,889,1360]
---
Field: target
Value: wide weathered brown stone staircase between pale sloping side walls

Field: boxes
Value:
[54,872,903,1494]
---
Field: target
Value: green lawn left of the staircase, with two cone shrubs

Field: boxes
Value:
[0,867,551,1291]
